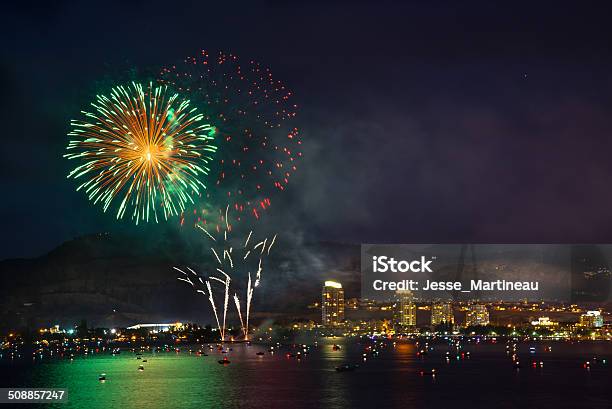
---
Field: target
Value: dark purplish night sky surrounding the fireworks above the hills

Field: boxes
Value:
[0,1,612,259]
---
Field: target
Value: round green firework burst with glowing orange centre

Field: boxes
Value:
[64,83,216,224]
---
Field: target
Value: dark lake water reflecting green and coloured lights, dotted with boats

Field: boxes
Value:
[2,338,612,409]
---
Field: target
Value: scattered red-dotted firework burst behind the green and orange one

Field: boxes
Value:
[159,51,302,223]
